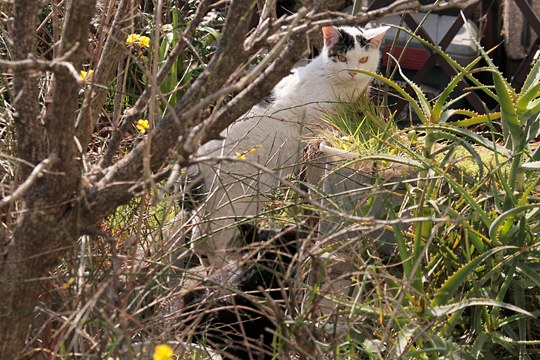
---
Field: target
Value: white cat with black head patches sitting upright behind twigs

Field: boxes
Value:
[188,26,389,267]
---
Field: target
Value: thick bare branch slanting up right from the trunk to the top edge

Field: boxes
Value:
[83,0,262,223]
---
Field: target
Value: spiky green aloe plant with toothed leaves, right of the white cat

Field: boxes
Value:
[320,23,540,359]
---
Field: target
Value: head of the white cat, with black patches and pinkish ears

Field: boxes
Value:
[322,26,389,82]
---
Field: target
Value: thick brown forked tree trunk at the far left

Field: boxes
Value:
[0,0,96,359]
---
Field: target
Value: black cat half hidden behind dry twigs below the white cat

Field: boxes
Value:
[179,224,309,359]
